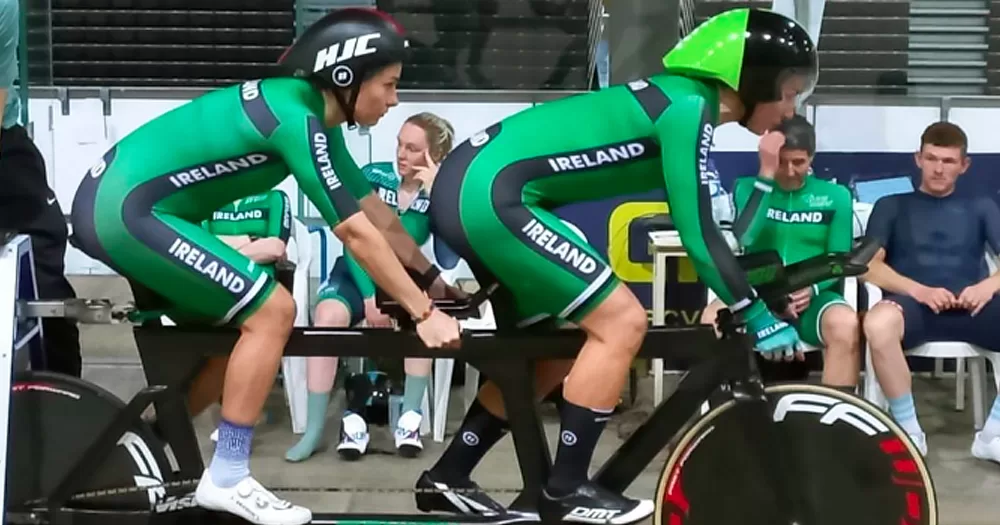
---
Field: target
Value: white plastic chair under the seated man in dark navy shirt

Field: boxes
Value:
[864,253,1000,429]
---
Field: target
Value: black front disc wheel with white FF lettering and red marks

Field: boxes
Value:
[654,384,938,525]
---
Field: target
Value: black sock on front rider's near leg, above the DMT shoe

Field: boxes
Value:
[547,401,612,497]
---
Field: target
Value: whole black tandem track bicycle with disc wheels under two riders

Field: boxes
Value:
[5,233,938,525]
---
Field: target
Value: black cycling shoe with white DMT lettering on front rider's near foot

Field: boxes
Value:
[538,481,654,525]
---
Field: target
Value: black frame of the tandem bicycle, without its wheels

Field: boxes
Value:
[0,233,873,523]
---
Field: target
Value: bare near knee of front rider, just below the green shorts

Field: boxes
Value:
[580,284,648,353]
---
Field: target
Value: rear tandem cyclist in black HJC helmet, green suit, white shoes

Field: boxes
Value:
[72,9,459,525]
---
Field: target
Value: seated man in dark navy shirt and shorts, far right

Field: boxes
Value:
[864,122,1000,462]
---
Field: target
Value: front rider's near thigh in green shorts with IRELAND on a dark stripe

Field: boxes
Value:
[461,196,618,325]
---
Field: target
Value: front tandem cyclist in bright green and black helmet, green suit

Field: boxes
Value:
[416,9,817,524]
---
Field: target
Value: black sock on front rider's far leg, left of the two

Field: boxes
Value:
[431,399,510,482]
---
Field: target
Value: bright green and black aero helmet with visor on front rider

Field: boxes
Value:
[663,8,819,125]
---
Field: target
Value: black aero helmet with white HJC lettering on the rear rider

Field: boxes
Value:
[278,7,409,126]
